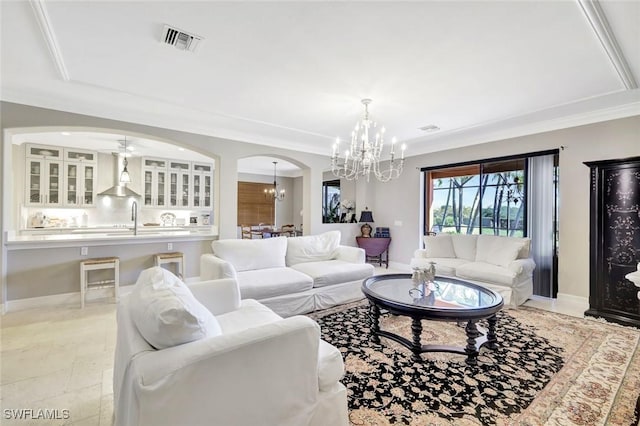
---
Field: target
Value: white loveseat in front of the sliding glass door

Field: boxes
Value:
[411,234,536,306]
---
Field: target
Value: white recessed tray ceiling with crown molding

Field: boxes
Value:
[0,0,640,155]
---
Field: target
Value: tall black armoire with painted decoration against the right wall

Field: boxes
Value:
[585,157,640,327]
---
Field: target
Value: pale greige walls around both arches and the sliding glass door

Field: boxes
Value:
[0,102,640,297]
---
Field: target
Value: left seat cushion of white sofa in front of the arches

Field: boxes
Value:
[238,268,313,299]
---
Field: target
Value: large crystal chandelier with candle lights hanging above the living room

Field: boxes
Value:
[331,99,406,182]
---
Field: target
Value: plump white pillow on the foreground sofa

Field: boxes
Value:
[129,266,221,349]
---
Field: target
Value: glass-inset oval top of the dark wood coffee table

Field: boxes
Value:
[362,274,504,320]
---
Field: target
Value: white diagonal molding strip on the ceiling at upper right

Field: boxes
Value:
[578,0,638,90]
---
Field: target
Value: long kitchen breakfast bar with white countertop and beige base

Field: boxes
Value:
[5,226,218,309]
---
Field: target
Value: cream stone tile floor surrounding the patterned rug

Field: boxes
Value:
[0,268,583,426]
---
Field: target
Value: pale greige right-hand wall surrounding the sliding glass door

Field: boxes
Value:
[376,116,640,297]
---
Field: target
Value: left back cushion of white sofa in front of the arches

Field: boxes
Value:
[211,237,287,272]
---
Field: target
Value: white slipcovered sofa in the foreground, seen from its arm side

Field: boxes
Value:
[114,267,348,426]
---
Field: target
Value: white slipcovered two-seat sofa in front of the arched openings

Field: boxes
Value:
[200,231,374,317]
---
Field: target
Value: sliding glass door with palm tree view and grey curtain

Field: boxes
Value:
[422,150,559,297]
